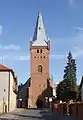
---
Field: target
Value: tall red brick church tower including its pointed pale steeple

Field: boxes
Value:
[28,12,50,108]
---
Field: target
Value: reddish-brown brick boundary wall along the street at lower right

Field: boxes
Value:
[55,102,83,120]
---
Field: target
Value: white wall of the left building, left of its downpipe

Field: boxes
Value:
[0,72,9,113]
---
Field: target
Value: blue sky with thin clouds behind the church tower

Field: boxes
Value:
[0,0,83,83]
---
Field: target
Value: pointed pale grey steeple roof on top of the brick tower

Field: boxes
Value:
[32,12,47,46]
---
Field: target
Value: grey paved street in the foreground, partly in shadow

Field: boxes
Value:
[0,109,75,120]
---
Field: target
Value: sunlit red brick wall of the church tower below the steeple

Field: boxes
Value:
[29,42,49,106]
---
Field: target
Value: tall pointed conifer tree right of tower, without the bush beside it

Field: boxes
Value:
[63,52,77,99]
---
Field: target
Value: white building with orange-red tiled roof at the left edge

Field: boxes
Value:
[0,64,17,113]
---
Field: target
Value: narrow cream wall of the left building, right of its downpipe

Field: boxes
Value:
[9,72,16,111]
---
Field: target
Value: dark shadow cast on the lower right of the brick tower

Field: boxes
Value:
[36,86,53,108]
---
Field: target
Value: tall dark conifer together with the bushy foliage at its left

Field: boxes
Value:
[57,52,77,100]
